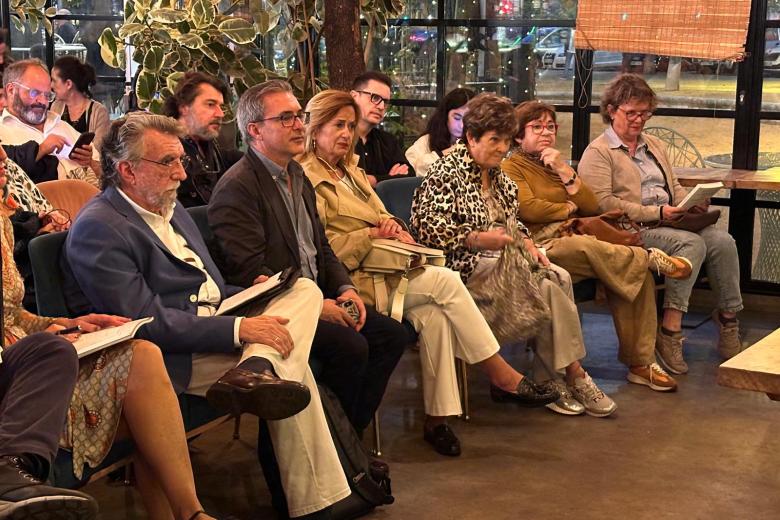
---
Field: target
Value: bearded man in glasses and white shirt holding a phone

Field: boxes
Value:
[0,59,100,186]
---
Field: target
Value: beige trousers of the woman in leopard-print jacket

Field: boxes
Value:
[467,256,585,381]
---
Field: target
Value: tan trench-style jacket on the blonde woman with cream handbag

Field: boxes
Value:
[298,153,397,305]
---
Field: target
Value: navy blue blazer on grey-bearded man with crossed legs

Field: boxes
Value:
[63,188,240,392]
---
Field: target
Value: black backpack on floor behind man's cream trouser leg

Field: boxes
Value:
[257,385,395,520]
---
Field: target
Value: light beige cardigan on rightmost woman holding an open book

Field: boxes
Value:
[577,129,687,222]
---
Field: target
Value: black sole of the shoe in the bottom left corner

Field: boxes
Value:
[0,496,98,520]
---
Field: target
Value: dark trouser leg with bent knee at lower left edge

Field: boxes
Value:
[0,332,79,468]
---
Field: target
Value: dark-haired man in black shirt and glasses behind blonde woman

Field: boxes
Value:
[350,71,414,186]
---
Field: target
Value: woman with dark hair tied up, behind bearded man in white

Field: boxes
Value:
[51,56,111,148]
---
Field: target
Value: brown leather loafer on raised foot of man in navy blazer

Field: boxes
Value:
[206,368,311,421]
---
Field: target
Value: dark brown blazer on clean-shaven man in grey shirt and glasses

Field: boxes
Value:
[208,150,352,298]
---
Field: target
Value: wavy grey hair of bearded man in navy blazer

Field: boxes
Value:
[100,112,185,189]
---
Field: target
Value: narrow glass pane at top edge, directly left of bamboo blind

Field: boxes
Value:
[440,0,577,20]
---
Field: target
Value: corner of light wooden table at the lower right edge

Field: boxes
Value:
[718,329,780,401]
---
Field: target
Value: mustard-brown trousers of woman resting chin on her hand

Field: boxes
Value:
[542,235,658,366]
